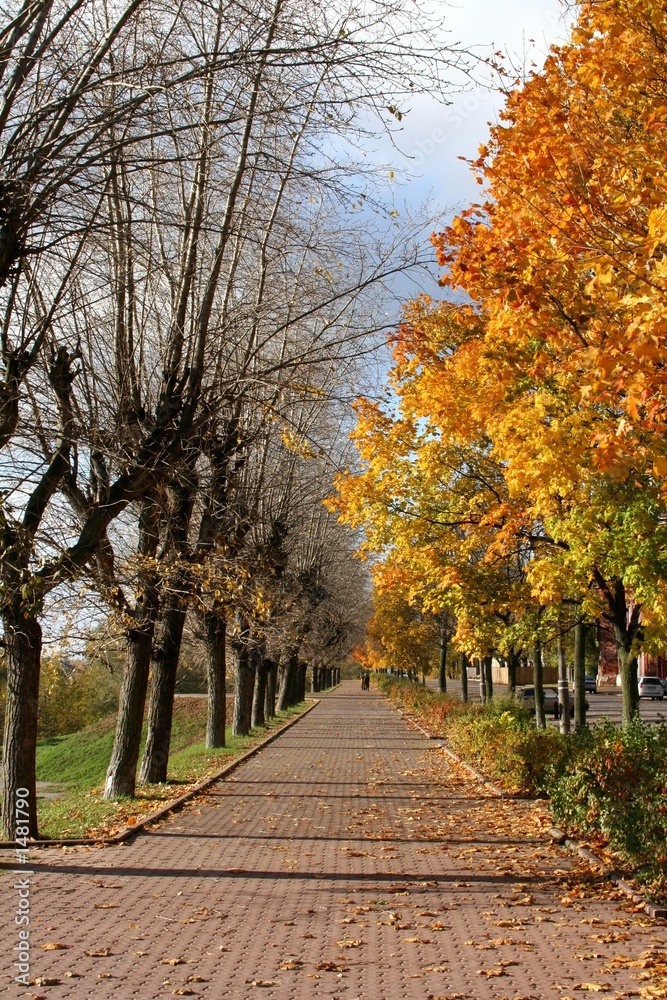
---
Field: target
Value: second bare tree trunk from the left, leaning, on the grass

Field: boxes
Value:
[104,496,158,799]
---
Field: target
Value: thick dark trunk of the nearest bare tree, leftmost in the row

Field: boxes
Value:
[2,601,42,840]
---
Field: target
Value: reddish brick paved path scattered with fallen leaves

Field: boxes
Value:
[0,682,667,1000]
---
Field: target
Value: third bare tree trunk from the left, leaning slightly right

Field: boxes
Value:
[139,588,186,782]
